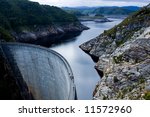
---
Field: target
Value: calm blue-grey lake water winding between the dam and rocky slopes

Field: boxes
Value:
[51,19,122,100]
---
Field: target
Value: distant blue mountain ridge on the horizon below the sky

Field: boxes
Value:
[62,6,140,15]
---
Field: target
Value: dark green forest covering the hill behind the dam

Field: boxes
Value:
[0,0,78,41]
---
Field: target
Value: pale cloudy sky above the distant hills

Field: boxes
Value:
[30,0,150,7]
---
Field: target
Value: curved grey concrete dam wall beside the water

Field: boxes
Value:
[1,43,76,100]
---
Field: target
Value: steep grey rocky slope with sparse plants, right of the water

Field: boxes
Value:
[80,5,150,99]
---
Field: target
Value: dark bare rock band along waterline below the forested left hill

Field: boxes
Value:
[12,22,89,46]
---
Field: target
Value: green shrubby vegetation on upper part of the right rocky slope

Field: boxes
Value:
[103,7,150,47]
